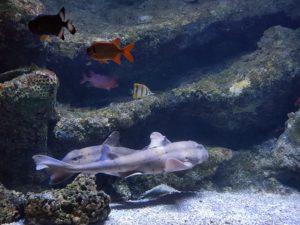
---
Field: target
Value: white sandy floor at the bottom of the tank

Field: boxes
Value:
[104,192,300,225]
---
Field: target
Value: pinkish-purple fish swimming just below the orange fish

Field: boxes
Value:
[80,71,118,91]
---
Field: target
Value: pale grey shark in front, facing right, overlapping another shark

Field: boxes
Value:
[32,132,208,183]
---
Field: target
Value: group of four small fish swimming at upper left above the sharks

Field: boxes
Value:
[28,7,153,99]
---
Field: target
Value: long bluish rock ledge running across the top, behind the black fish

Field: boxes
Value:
[37,0,297,57]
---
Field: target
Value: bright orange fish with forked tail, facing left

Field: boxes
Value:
[87,38,134,65]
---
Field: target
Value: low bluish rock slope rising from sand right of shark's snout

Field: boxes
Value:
[212,138,292,194]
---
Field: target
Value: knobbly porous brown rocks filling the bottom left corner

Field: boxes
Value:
[0,175,110,225]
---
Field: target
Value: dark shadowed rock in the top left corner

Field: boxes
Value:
[0,0,44,72]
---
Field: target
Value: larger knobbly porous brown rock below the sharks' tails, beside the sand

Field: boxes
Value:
[25,174,110,225]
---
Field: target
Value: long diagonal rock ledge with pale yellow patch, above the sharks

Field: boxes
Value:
[54,26,300,147]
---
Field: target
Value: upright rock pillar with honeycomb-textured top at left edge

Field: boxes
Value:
[0,69,58,184]
